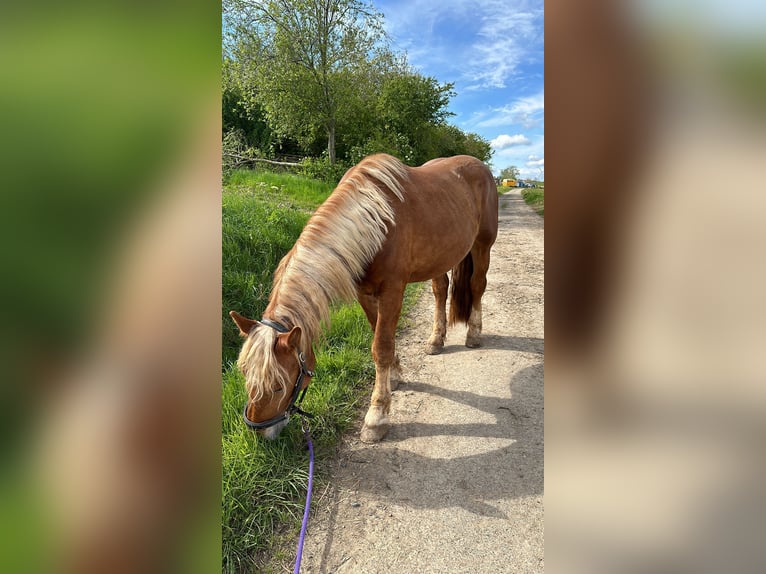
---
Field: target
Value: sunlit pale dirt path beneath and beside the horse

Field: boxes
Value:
[302,191,543,574]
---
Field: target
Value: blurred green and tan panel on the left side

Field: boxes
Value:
[0,2,221,573]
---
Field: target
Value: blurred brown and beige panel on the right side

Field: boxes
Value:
[545,0,766,574]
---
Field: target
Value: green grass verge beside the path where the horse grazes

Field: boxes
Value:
[221,170,420,573]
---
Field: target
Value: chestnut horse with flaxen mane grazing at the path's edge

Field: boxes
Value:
[229,154,498,443]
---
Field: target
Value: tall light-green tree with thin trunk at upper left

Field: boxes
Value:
[224,0,383,163]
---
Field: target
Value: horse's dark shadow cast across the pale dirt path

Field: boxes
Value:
[332,363,543,518]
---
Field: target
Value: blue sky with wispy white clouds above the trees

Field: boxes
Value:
[373,0,545,179]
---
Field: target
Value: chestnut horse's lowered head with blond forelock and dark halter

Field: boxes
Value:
[229,311,314,439]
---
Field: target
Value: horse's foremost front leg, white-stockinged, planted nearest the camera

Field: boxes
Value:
[361,285,404,442]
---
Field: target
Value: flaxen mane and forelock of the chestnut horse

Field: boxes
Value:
[238,154,408,398]
